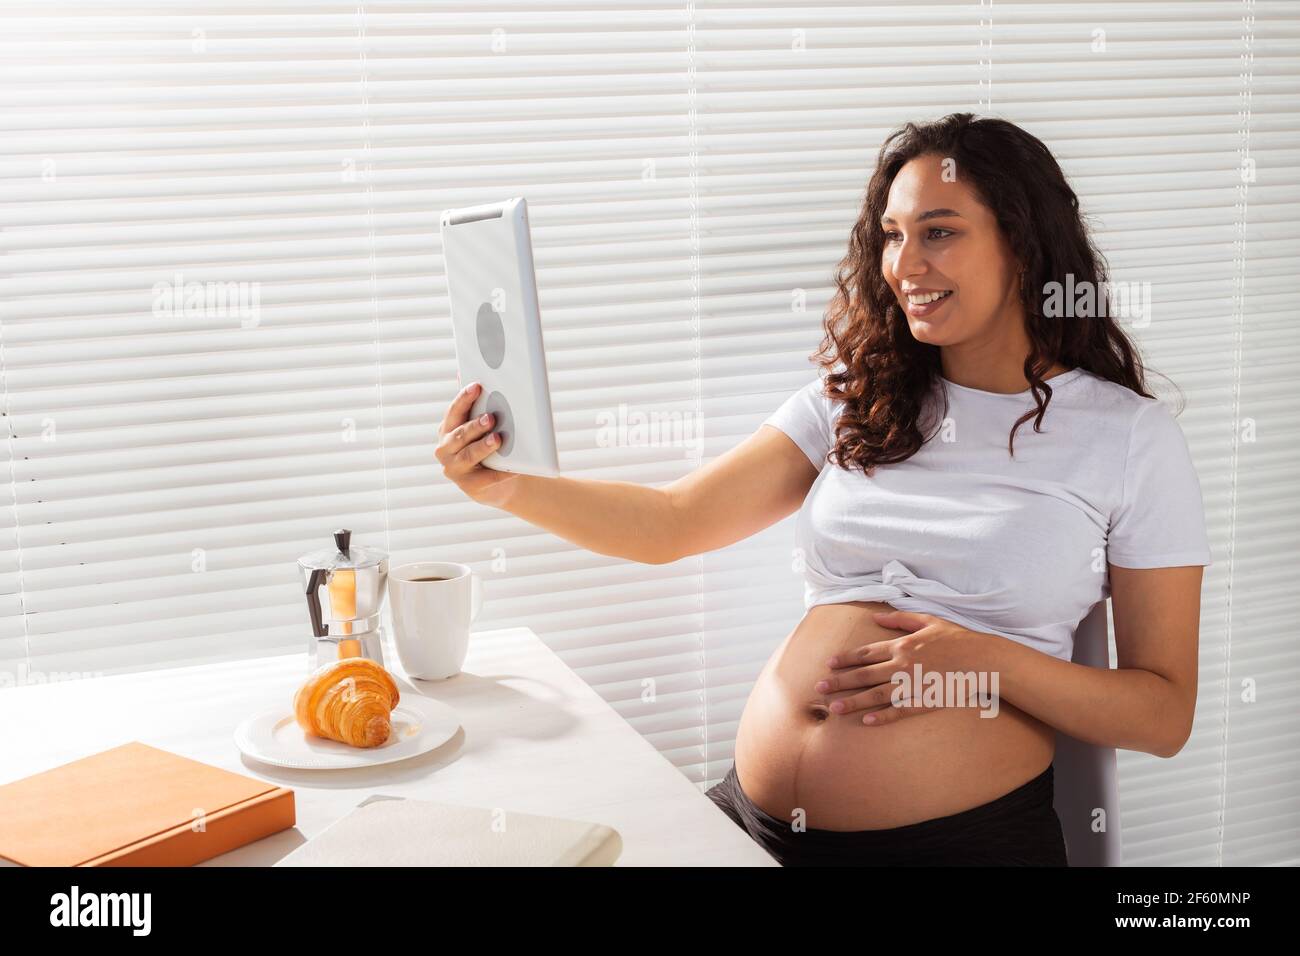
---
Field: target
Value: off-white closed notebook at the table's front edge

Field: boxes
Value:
[276,795,623,866]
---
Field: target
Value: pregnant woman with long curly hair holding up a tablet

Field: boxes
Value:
[437,113,1210,865]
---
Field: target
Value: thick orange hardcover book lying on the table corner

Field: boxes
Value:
[0,741,295,866]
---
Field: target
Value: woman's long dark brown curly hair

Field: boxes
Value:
[811,113,1170,475]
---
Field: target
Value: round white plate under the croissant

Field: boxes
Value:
[235,693,460,770]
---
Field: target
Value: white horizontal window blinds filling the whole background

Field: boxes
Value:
[0,0,1300,865]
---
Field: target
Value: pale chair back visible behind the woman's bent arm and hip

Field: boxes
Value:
[1053,600,1121,866]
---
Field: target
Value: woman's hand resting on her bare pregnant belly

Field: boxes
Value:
[813,610,997,726]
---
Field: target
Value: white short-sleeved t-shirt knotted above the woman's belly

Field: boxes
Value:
[763,368,1212,661]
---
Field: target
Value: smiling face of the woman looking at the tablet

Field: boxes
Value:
[879,155,1023,349]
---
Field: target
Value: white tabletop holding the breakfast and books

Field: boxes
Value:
[0,627,776,866]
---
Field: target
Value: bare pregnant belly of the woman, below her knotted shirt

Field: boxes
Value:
[736,601,1056,830]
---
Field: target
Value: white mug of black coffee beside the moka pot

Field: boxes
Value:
[389,561,482,680]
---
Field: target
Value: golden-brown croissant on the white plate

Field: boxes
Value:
[294,657,399,747]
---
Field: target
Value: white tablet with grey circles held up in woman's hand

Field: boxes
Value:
[442,196,560,477]
